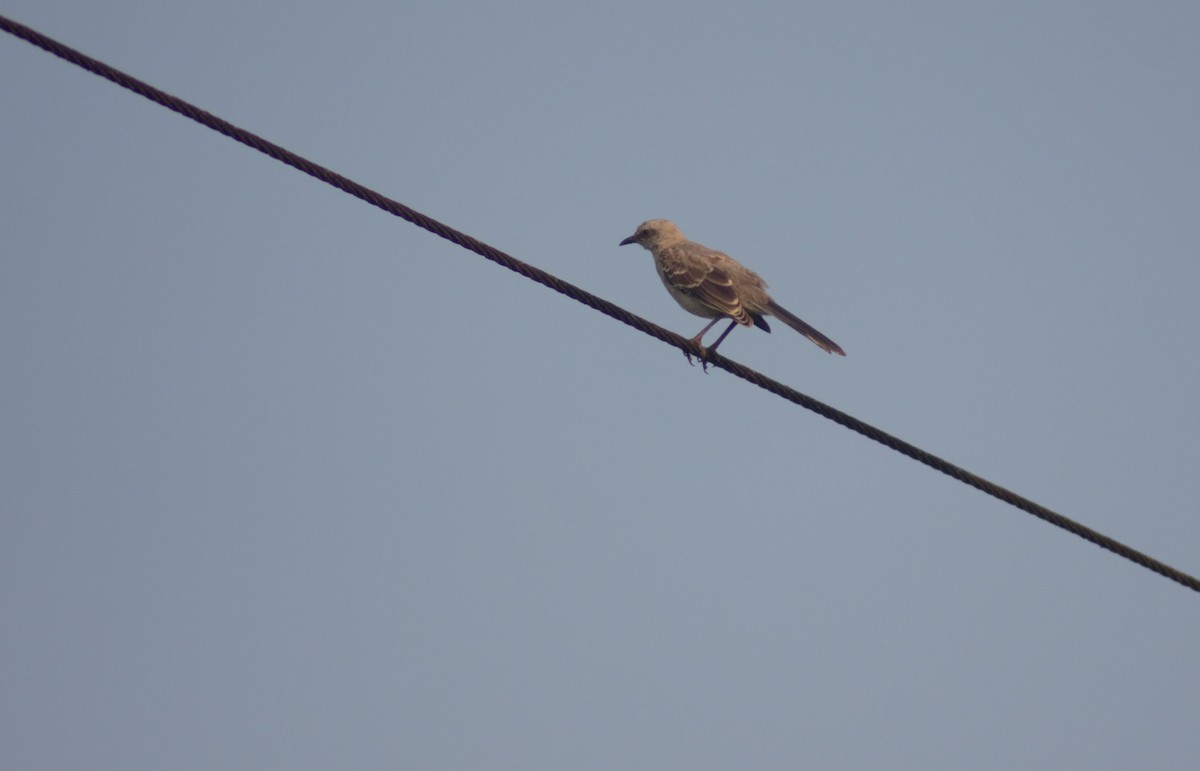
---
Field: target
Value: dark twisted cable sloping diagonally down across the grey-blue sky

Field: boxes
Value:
[0,16,1200,592]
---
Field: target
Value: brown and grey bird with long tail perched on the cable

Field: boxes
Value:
[620,220,846,370]
